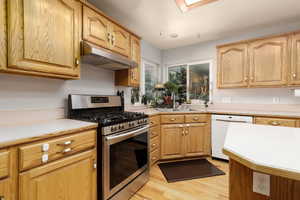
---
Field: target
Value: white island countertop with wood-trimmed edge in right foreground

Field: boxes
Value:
[224,123,300,181]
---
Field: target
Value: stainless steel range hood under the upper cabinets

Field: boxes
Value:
[81,41,138,70]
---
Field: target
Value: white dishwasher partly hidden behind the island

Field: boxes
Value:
[211,115,253,160]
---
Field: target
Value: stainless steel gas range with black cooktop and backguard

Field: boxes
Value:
[69,95,149,200]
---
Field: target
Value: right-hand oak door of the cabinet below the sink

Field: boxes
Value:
[185,123,210,156]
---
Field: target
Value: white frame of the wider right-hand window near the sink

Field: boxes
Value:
[166,60,213,104]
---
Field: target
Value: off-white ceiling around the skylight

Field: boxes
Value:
[89,0,300,49]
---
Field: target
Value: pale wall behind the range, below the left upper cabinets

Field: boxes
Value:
[0,65,114,111]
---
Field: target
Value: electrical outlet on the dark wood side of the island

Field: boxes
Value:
[253,172,271,196]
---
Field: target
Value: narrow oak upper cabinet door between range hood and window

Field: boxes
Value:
[130,36,141,87]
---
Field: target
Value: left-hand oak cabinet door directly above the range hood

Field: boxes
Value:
[83,6,110,48]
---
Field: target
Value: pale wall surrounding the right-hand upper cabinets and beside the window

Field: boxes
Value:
[163,22,300,104]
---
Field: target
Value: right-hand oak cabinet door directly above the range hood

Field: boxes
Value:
[110,24,130,57]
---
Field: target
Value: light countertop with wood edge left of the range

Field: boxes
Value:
[0,119,98,148]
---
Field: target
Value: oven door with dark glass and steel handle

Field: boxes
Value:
[102,125,149,200]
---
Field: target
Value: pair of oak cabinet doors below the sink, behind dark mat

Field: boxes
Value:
[161,123,211,159]
